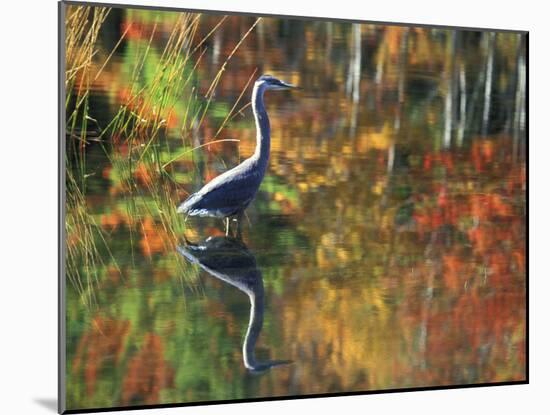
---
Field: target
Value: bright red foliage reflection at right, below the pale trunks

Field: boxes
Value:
[415,145,525,382]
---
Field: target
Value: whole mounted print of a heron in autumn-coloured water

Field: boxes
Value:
[59,2,528,413]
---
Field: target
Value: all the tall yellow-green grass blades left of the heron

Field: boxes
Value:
[65,1,259,303]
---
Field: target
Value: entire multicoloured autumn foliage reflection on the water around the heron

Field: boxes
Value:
[67,5,526,406]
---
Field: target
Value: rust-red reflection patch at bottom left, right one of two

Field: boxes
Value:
[122,333,174,405]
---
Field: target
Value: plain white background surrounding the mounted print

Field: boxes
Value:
[0,0,550,415]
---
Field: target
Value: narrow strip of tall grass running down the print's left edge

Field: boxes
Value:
[65,7,109,305]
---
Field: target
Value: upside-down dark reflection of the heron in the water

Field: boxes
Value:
[178,236,291,373]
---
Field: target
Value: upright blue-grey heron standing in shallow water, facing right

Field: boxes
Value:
[177,75,297,236]
